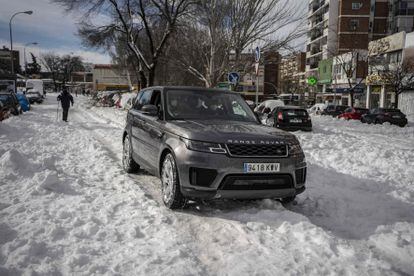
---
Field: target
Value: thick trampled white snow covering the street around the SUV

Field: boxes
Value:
[0,94,414,275]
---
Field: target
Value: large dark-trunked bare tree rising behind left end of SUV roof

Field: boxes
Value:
[54,0,193,87]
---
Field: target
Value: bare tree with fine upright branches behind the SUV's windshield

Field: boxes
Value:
[176,0,304,87]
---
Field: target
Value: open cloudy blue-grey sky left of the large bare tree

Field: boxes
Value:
[0,0,308,64]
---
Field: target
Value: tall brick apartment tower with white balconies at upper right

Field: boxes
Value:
[306,0,392,78]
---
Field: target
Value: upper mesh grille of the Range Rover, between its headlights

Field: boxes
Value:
[226,144,288,157]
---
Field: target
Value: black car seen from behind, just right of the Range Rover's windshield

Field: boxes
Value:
[266,106,312,131]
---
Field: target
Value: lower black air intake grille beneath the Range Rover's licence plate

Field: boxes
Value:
[220,174,293,191]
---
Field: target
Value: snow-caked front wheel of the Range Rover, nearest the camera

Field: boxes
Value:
[161,153,187,209]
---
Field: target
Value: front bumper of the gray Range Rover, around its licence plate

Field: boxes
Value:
[175,144,306,199]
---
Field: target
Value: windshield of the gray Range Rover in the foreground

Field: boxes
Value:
[166,90,257,122]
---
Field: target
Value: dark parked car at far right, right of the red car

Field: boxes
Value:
[361,108,408,127]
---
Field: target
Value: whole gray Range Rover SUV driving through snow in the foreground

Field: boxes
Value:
[122,87,306,209]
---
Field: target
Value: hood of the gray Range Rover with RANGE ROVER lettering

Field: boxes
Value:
[167,120,295,144]
